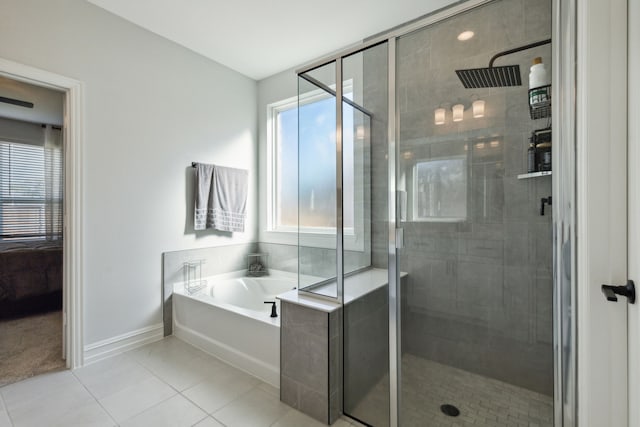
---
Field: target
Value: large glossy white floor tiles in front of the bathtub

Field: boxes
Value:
[0,337,359,427]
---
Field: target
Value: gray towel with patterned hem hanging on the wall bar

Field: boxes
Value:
[194,163,249,231]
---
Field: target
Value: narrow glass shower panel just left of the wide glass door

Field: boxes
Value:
[342,42,390,426]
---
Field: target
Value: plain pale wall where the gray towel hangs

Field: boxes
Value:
[0,0,257,345]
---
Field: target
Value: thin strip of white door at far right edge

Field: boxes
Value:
[628,0,640,427]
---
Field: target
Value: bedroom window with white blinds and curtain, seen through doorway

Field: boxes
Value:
[0,138,63,241]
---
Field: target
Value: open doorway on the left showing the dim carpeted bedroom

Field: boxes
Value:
[0,77,66,386]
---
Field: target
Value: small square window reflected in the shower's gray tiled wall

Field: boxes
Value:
[413,156,467,222]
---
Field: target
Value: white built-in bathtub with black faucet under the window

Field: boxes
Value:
[173,271,297,387]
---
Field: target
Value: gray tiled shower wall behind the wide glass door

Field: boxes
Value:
[365,0,553,395]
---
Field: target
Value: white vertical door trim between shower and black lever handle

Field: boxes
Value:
[576,0,628,427]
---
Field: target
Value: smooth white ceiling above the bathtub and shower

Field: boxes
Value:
[88,0,456,80]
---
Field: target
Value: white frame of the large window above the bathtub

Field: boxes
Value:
[265,82,365,251]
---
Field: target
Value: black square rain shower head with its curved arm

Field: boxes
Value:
[456,39,551,89]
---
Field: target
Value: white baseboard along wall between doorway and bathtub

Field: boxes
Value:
[84,323,164,365]
